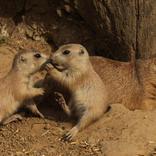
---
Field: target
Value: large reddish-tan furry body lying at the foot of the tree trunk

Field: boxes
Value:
[91,57,156,110]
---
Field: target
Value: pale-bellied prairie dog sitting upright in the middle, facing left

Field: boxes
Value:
[46,44,108,141]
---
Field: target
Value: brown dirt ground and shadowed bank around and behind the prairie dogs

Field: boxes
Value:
[0,0,156,156]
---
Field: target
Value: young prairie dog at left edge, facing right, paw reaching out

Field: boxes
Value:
[0,50,47,124]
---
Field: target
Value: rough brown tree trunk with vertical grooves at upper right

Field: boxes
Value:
[74,0,156,59]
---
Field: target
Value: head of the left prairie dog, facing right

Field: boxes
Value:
[13,50,48,75]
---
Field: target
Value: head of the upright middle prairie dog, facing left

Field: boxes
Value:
[51,44,90,71]
